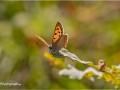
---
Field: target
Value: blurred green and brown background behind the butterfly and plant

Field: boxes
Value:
[0,1,120,89]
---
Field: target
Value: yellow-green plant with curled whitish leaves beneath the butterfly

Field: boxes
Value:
[45,49,120,88]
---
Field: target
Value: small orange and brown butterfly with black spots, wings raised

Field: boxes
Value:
[36,22,68,58]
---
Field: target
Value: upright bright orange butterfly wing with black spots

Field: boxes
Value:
[52,22,63,45]
